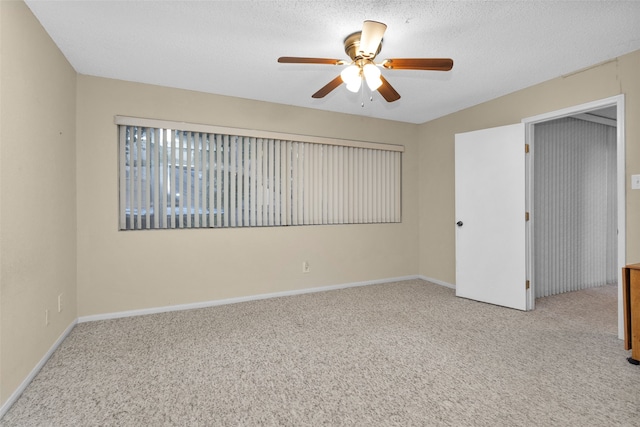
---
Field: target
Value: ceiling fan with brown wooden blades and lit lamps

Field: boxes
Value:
[278,21,453,102]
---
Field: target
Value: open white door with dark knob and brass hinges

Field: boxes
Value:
[454,124,527,310]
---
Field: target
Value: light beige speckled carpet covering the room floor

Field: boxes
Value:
[0,280,640,426]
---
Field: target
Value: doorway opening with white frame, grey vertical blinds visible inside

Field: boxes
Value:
[523,95,626,338]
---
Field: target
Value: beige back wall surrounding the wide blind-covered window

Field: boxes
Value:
[77,76,418,316]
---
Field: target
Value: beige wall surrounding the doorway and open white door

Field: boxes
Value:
[419,51,640,284]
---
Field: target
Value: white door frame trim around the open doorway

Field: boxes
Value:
[522,94,626,339]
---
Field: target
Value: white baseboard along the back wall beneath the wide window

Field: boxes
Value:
[78,276,421,323]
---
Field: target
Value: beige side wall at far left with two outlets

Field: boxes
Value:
[0,1,77,405]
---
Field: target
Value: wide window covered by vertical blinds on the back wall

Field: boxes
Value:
[116,116,404,230]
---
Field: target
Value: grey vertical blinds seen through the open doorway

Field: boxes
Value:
[534,118,618,298]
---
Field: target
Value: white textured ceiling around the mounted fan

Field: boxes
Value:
[26,0,640,123]
